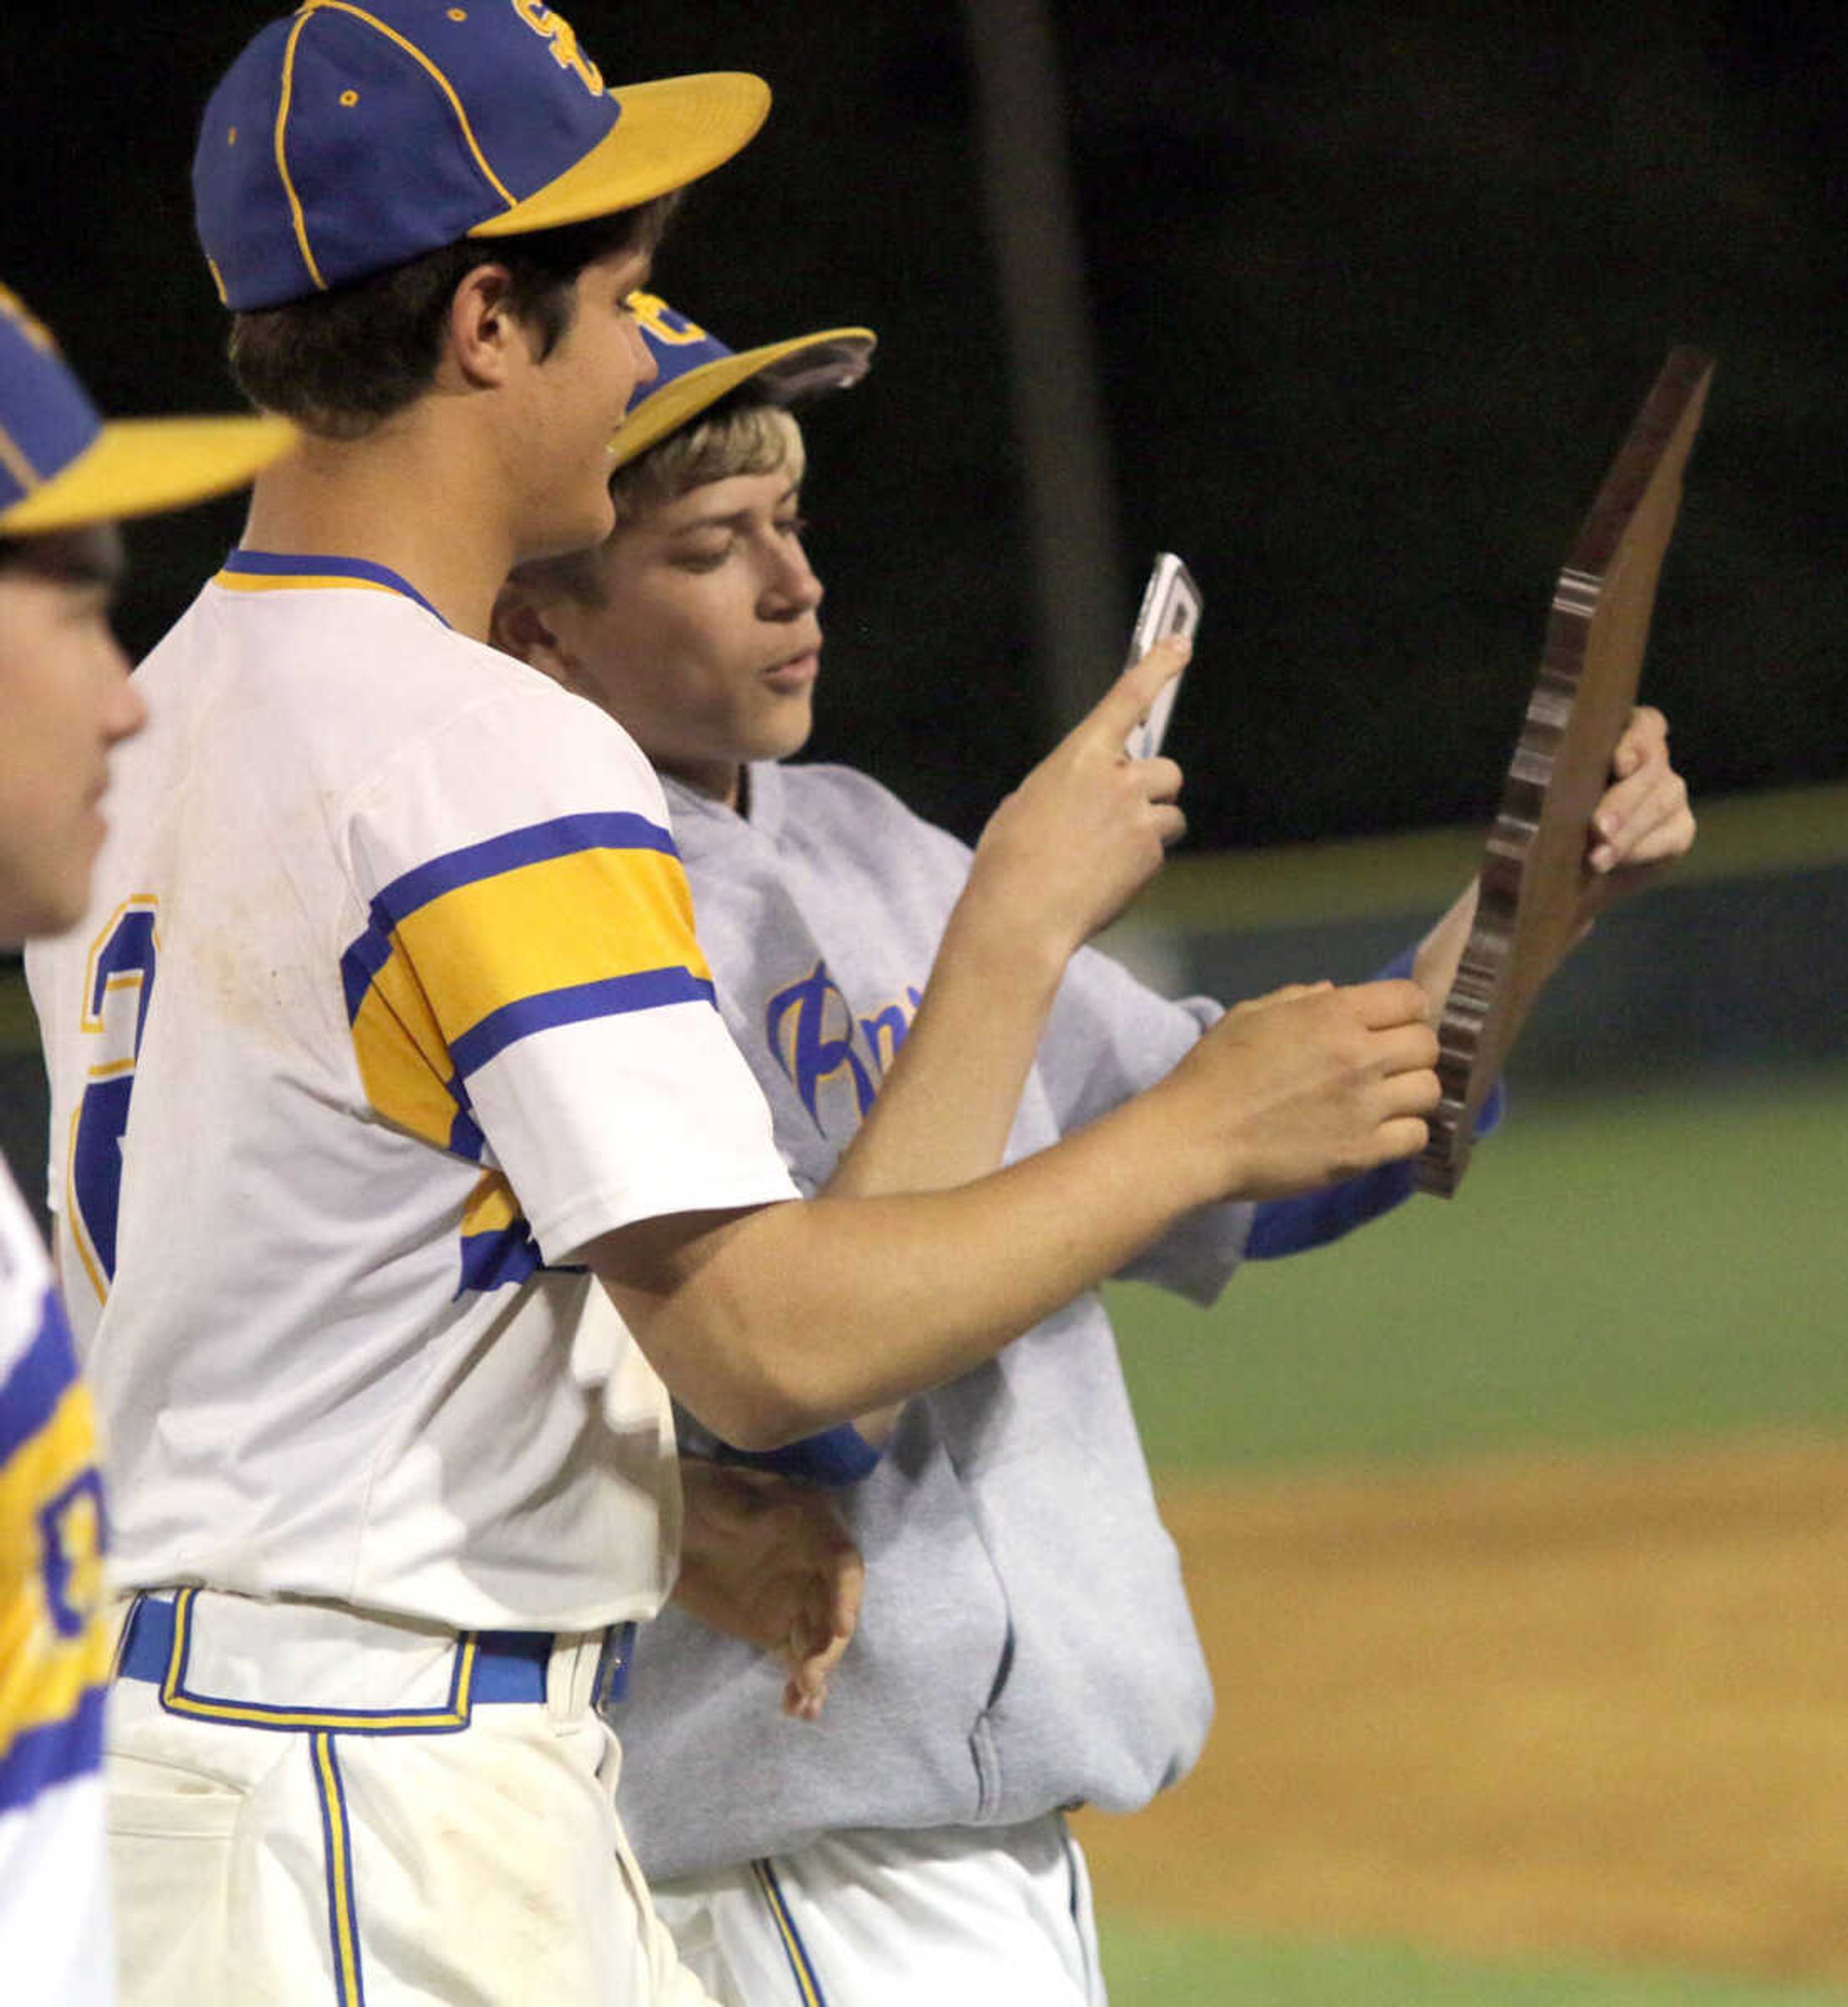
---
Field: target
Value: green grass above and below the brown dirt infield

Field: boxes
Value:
[1104,1070,1848,2007]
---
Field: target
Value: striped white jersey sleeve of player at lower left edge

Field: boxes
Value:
[0,1162,115,2007]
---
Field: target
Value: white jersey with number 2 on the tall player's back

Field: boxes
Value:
[28,552,793,1630]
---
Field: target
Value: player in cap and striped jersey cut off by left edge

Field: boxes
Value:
[0,287,293,2007]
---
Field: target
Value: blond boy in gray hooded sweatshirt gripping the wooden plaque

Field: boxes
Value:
[496,299,1694,2007]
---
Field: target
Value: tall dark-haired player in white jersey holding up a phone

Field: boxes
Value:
[30,0,1437,2003]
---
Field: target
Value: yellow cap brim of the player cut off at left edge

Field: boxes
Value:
[0,417,297,536]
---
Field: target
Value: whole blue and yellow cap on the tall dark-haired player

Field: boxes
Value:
[192,0,770,311]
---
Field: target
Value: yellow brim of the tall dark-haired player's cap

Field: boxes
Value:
[470,70,770,237]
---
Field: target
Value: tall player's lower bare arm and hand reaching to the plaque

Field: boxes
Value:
[588,981,1437,1449]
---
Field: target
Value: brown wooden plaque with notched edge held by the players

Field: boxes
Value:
[1414,349,1714,1198]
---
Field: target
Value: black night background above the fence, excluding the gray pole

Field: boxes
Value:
[0,0,1848,845]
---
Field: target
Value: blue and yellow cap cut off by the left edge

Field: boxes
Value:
[0,285,297,536]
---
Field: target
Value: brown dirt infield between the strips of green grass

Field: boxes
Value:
[1079,1441,1848,1983]
